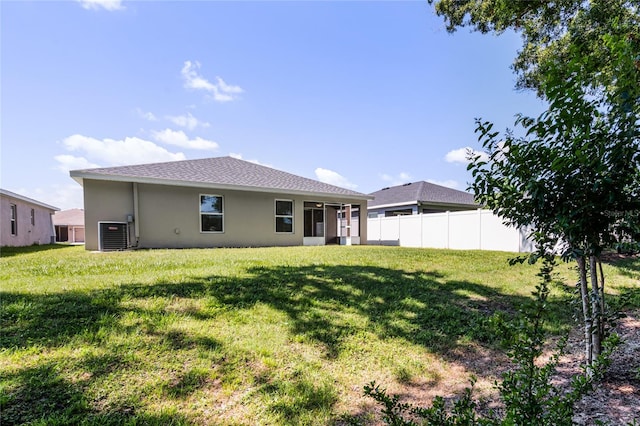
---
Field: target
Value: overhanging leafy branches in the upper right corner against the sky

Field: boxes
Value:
[428,0,640,97]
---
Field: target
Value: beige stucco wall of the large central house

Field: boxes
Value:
[84,179,367,250]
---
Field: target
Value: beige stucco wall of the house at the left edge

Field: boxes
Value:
[0,195,55,247]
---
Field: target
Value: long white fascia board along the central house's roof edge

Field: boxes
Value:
[70,171,373,201]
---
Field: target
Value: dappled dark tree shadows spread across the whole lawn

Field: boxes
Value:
[0,264,576,424]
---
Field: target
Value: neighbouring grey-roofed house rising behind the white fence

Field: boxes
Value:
[367,181,481,218]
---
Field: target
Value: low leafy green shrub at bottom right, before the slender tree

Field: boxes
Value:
[364,259,619,426]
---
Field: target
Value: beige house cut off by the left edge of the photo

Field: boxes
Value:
[0,189,60,247]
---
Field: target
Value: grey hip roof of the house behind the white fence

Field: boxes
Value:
[368,181,479,209]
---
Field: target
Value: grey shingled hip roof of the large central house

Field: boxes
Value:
[70,157,372,200]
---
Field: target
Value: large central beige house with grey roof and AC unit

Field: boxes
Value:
[70,157,372,250]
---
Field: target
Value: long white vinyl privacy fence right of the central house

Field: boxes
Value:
[367,209,533,252]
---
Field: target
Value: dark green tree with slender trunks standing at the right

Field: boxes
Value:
[469,31,640,365]
